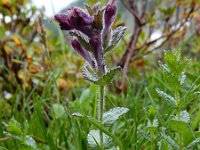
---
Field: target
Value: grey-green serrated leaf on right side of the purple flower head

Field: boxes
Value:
[104,26,127,53]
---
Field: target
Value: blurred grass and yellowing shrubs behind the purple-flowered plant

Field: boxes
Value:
[0,0,200,150]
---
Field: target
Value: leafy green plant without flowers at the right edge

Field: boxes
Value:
[155,50,200,150]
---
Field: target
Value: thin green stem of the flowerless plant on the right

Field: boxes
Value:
[175,92,183,150]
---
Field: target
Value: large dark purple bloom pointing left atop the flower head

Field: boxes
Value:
[54,7,94,37]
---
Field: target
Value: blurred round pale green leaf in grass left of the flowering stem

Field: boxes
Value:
[52,104,66,119]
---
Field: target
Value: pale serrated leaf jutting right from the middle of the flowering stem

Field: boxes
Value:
[103,107,129,126]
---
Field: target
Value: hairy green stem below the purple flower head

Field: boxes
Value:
[98,86,105,148]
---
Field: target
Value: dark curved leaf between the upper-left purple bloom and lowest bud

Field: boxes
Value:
[69,31,92,52]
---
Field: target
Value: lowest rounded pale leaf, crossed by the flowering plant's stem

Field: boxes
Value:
[87,130,112,149]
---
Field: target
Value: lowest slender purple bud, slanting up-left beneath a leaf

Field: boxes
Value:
[71,38,93,66]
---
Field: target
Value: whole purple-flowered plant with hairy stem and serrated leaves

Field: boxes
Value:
[54,0,128,148]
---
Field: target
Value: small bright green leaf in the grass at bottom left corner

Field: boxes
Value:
[6,118,22,136]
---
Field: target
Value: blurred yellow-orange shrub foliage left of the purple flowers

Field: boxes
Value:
[0,0,87,93]
